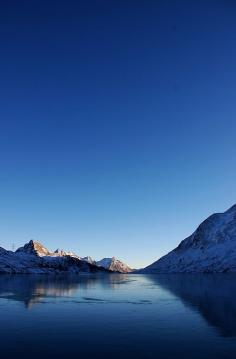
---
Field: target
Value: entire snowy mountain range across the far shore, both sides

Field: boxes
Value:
[0,205,236,274]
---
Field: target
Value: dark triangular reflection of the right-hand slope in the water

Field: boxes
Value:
[148,274,236,336]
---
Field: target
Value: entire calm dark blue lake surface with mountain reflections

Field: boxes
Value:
[0,274,236,359]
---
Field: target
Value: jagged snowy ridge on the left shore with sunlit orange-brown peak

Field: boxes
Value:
[0,240,109,274]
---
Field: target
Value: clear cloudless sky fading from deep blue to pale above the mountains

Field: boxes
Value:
[0,0,236,267]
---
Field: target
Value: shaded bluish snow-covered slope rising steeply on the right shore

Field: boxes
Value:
[138,205,236,273]
